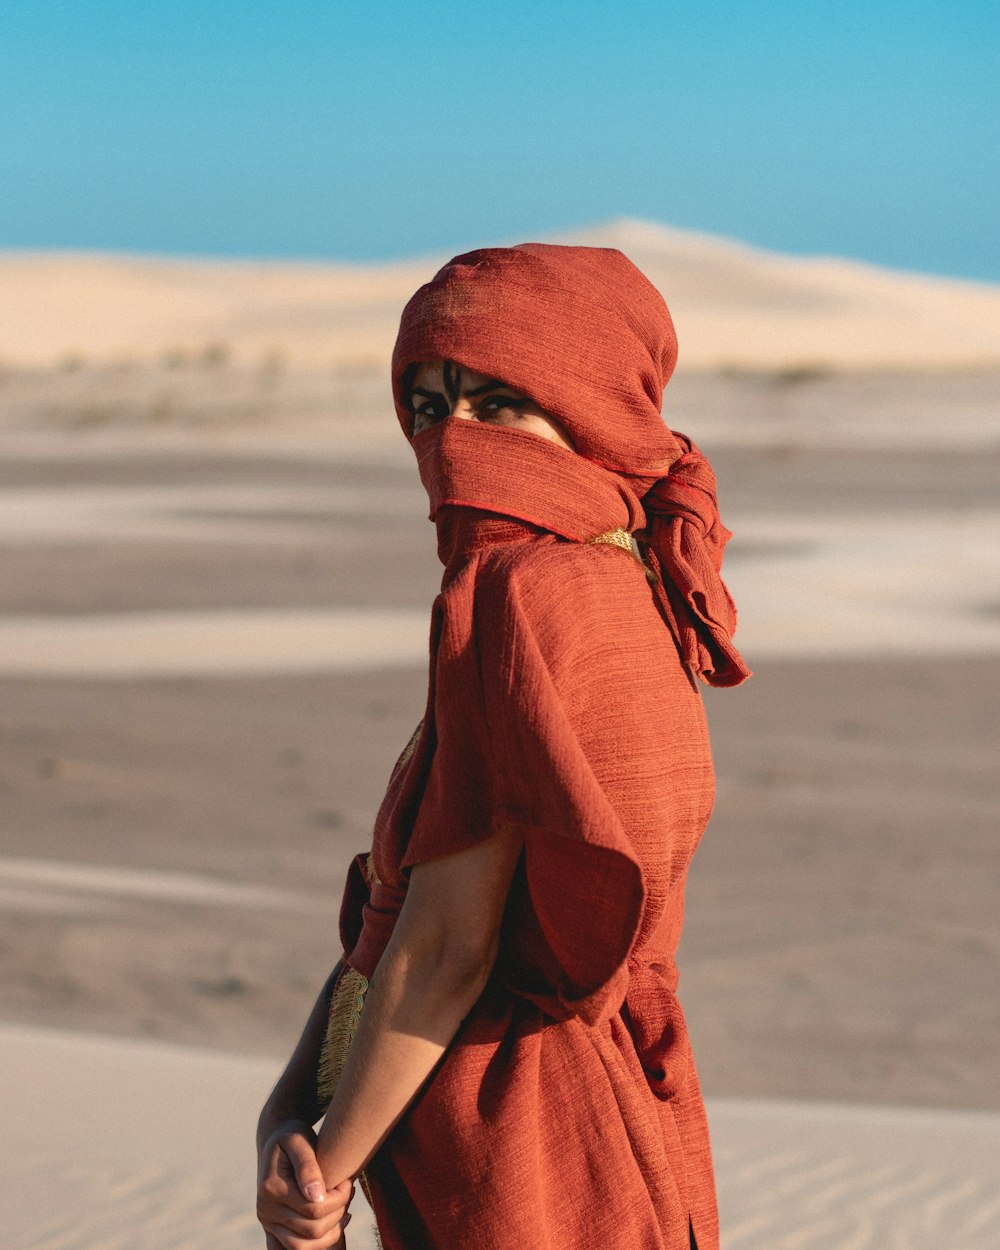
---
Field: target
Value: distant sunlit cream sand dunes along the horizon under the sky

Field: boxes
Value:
[7,221,1000,369]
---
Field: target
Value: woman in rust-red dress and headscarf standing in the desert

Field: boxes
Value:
[259,244,749,1250]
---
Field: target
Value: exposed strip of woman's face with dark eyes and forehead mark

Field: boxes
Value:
[410,360,574,451]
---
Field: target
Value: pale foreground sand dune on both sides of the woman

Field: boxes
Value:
[0,1025,1000,1250]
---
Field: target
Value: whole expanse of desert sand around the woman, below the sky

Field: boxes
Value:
[0,224,1000,1250]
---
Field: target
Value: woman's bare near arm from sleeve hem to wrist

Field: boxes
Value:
[316,830,521,1185]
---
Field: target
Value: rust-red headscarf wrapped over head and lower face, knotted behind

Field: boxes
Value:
[393,244,749,686]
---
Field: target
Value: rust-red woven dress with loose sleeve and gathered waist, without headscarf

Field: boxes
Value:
[341,509,718,1250]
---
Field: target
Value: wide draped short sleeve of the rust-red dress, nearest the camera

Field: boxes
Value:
[405,557,645,1023]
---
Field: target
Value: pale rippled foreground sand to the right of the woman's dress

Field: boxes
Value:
[710,1100,1000,1250]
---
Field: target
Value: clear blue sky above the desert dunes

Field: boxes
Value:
[0,0,1000,281]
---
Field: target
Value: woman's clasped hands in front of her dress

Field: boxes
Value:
[258,1120,354,1250]
